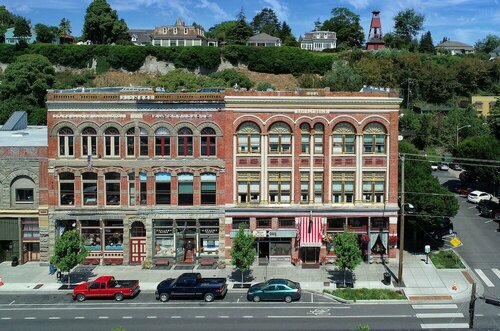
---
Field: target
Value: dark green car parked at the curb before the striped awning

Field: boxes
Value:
[247,279,301,302]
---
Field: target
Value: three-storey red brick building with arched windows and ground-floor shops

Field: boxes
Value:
[44,88,401,264]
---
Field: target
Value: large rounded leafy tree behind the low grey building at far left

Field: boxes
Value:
[0,54,55,125]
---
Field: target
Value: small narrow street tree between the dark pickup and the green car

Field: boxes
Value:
[231,224,255,287]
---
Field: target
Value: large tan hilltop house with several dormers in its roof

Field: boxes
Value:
[151,18,217,47]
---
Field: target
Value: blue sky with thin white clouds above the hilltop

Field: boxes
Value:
[0,0,500,45]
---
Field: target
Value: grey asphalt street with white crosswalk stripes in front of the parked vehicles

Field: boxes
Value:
[0,292,500,331]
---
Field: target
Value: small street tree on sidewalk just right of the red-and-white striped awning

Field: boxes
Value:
[333,228,361,286]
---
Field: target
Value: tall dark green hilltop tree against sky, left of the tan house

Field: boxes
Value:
[83,0,128,44]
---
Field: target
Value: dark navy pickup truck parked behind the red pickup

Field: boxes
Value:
[155,273,227,302]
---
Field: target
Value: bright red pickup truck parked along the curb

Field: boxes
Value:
[73,276,140,302]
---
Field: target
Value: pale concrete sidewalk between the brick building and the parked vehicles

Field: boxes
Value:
[0,252,472,301]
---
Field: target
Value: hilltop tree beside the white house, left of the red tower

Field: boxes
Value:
[321,8,365,49]
